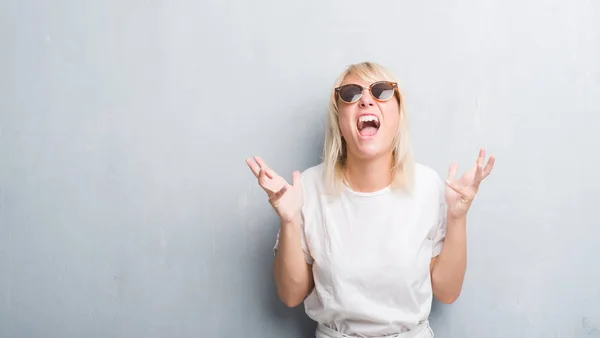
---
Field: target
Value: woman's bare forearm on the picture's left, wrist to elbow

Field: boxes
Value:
[274,220,313,307]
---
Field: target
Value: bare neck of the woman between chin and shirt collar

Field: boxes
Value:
[345,153,393,192]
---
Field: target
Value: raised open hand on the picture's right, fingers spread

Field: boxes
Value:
[446,148,496,218]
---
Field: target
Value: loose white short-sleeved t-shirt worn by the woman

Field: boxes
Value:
[275,163,446,337]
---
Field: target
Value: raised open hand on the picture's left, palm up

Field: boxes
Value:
[246,156,303,223]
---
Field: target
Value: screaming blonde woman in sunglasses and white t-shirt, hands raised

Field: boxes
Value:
[246,63,494,338]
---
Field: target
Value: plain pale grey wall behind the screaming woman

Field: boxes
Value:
[0,0,600,338]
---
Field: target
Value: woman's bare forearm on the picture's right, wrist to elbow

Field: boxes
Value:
[431,215,467,303]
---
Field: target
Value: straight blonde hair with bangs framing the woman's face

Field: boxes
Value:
[323,62,414,194]
